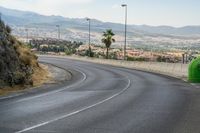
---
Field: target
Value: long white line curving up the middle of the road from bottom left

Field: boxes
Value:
[15,79,131,133]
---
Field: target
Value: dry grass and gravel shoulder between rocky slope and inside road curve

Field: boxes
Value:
[0,63,72,100]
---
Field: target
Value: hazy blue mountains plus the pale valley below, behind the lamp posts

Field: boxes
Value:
[0,7,200,51]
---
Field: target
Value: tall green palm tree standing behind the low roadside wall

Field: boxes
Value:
[101,29,115,59]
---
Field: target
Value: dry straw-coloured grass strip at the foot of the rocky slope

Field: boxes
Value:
[0,64,52,95]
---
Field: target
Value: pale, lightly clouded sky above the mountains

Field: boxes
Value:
[0,0,200,27]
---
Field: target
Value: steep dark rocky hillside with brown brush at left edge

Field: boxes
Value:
[0,21,39,88]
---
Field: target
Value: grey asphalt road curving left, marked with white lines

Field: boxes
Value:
[0,57,200,133]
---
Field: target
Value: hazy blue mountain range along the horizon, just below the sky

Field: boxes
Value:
[0,7,200,36]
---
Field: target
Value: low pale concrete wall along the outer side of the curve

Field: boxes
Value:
[38,55,188,82]
